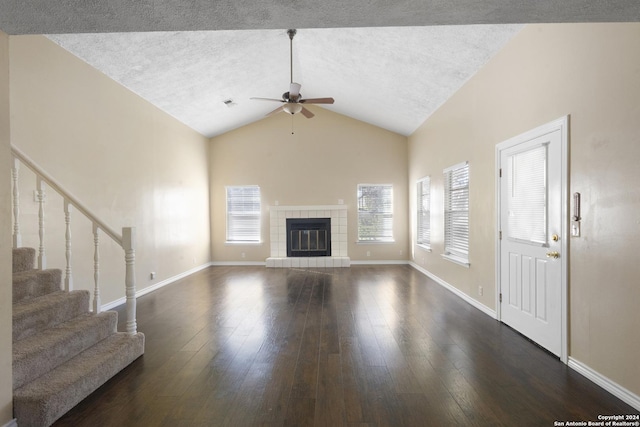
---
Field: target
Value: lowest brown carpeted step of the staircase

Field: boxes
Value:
[13,332,144,427]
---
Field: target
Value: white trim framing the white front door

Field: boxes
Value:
[495,115,569,364]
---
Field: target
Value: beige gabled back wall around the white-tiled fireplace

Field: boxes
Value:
[211,106,409,262]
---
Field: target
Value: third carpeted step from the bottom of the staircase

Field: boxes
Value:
[13,290,90,342]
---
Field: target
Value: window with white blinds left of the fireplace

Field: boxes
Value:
[226,185,261,243]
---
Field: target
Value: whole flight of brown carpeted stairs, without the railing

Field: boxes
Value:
[13,248,144,427]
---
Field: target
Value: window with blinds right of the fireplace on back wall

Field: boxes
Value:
[358,184,393,242]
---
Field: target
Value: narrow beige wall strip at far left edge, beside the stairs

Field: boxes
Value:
[0,31,13,425]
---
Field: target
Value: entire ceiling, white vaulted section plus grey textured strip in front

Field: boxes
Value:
[0,0,640,136]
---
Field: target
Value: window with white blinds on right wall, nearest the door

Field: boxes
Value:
[444,162,469,266]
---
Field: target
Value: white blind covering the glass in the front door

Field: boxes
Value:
[506,145,547,244]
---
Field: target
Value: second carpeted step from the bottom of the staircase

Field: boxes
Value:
[13,311,118,389]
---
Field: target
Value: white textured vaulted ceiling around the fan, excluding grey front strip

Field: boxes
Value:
[49,26,519,136]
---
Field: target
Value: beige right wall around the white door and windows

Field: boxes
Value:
[409,23,640,395]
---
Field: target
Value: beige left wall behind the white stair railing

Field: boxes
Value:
[10,36,210,304]
